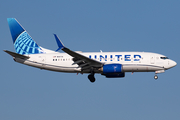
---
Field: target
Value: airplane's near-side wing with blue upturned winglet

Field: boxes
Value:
[54,34,103,70]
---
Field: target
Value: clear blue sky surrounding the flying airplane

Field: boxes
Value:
[0,0,180,120]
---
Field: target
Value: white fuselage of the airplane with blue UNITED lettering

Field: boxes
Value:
[14,52,176,73]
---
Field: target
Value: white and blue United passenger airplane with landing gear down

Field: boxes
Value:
[4,18,177,82]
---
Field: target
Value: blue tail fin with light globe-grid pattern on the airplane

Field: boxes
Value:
[7,18,44,55]
